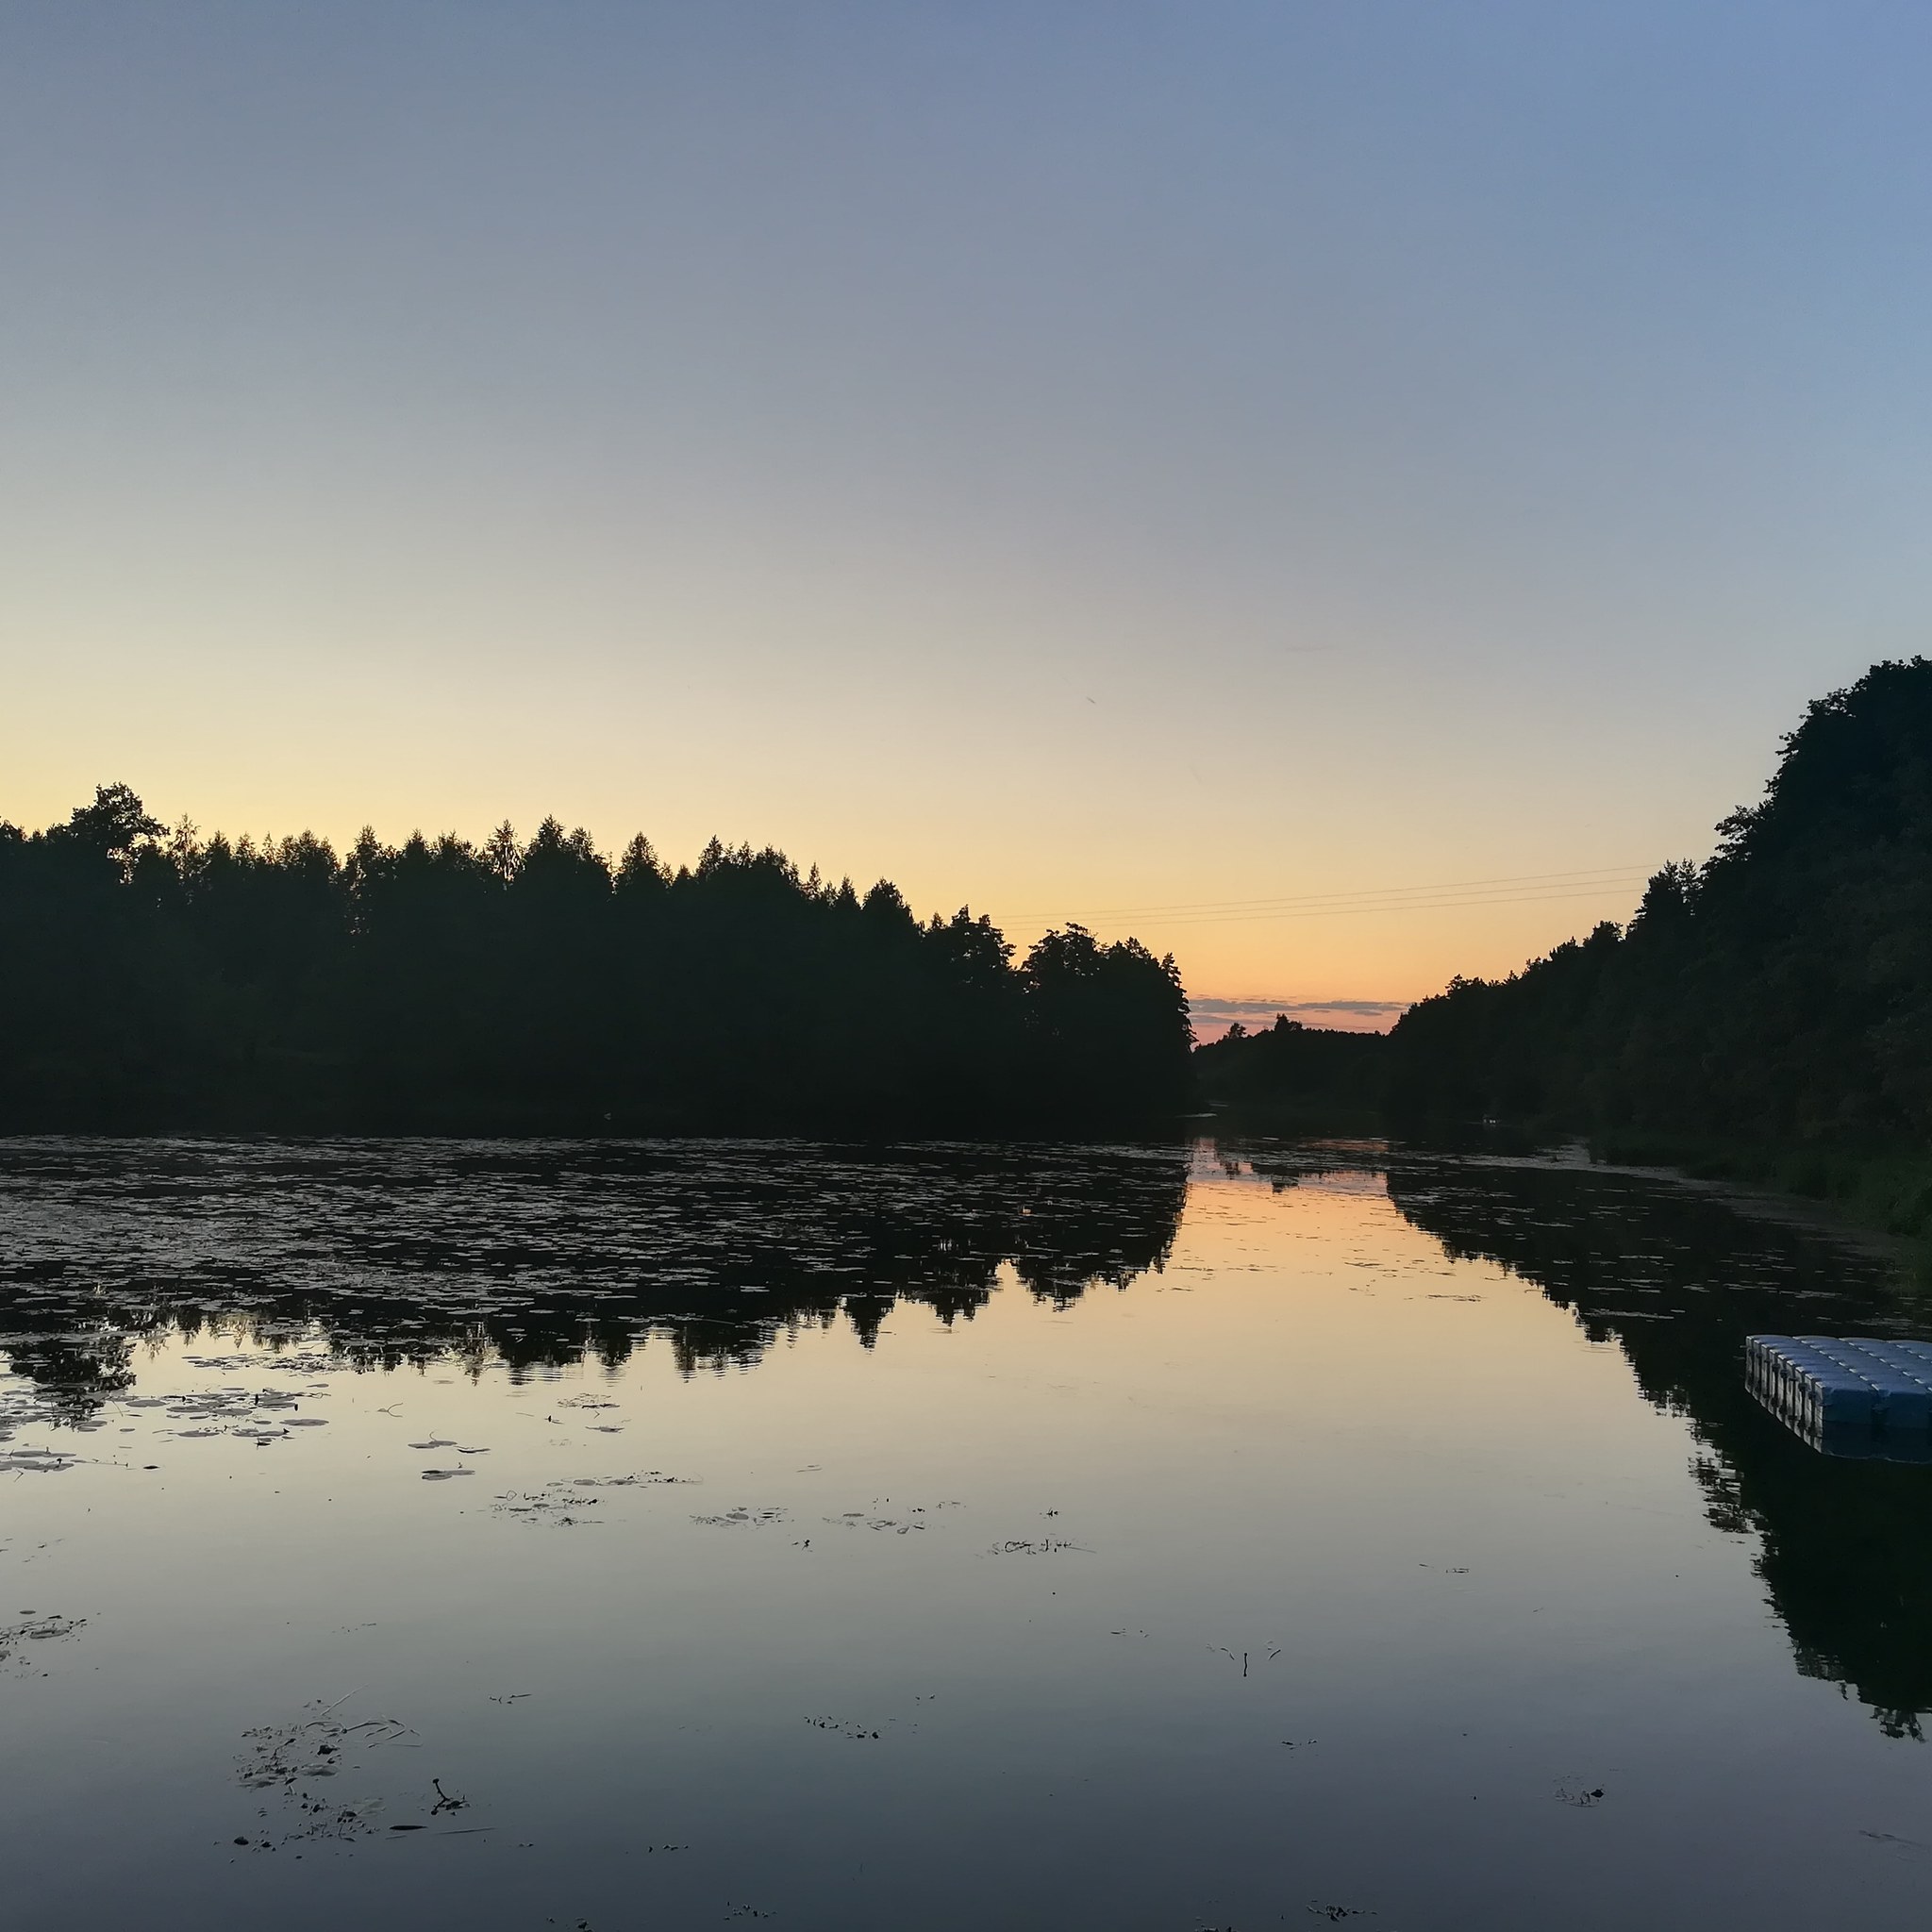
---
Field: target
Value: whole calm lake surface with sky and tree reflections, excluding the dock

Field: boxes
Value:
[0,1141,1932,1932]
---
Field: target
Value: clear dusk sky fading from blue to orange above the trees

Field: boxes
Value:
[0,0,1932,1024]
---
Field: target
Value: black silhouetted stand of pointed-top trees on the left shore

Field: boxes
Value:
[0,787,1192,1132]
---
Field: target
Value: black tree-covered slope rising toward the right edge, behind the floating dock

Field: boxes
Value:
[1198,657,1932,1166]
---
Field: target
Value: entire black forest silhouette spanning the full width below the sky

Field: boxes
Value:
[23,657,1932,1143]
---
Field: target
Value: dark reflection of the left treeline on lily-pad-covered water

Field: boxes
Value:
[0,1140,1186,1420]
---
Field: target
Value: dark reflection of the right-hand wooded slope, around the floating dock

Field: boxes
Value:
[1390,1161,1932,1737]
